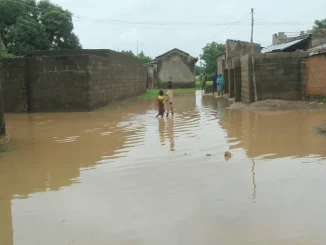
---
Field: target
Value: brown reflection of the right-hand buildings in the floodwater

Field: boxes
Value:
[220,110,326,159]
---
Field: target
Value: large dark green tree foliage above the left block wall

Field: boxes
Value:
[0,0,81,56]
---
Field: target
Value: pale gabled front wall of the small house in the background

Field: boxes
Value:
[157,52,195,88]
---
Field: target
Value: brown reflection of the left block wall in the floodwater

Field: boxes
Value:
[0,103,147,245]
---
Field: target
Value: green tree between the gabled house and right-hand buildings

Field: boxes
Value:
[200,42,225,73]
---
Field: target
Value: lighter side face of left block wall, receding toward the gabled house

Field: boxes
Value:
[88,52,147,108]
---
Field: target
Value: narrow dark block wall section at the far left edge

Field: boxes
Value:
[0,58,27,112]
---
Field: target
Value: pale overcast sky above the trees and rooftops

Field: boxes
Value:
[53,0,326,57]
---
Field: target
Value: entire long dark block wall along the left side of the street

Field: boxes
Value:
[0,51,146,112]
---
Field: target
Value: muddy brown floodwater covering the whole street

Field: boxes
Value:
[0,92,326,245]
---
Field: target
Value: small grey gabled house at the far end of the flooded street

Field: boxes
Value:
[145,48,198,89]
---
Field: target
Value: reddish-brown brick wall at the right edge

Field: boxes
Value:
[305,54,326,96]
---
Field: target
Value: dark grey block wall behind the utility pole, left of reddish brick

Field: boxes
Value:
[241,52,309,103]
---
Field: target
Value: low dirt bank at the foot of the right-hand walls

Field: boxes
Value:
[228,100,326,111]
